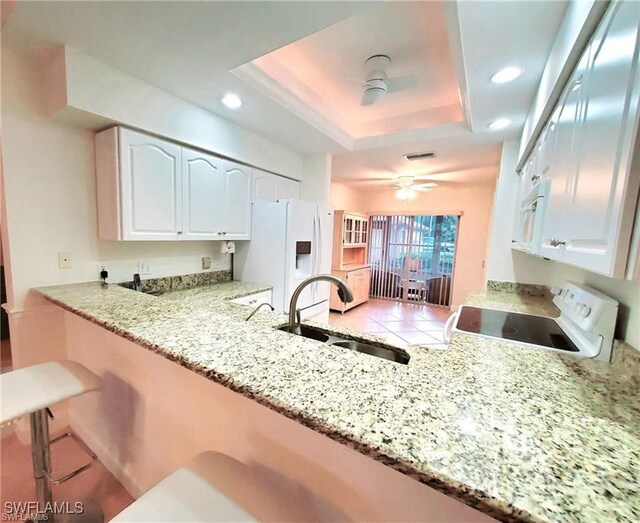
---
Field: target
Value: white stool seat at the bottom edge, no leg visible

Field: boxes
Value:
[111,452,283,523]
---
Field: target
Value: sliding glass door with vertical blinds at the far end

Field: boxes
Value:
[369,215,458,306]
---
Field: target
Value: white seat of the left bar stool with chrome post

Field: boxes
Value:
[0,361,102,425]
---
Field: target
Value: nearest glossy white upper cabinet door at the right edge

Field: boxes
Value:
[562,1,640,277]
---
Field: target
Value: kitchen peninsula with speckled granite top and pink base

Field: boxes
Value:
[36,281,640,521]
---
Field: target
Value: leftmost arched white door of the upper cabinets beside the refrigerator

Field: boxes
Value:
[120,129,182,240]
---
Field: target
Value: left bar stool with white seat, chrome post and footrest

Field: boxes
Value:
[0,361,102,521]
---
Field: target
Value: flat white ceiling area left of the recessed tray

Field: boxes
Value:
[2,0,380,153]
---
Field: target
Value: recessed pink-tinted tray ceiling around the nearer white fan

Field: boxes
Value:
[240,2,463,140]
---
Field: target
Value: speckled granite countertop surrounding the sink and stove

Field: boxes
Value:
[31,282,640,523]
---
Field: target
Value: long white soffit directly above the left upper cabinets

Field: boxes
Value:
[46,47,305,180]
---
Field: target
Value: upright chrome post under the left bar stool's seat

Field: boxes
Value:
[30,409,53,521]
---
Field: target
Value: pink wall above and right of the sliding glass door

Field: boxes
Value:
[331,183,495,307]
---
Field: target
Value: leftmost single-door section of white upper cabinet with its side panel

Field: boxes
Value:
[96,128,182,241]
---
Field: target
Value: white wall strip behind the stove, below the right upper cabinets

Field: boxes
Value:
[487,140,640,348]
